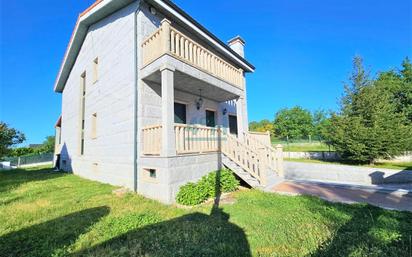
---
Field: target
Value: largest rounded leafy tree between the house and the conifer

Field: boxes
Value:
[274,106,313,139]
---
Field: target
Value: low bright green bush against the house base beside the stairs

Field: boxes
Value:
[176,169,239,205]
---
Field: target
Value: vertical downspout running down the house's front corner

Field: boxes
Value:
[133,6,140,192]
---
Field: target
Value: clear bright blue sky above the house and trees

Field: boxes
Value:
[0,0,412,144]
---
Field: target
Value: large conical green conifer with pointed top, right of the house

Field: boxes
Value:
[328,57,412,163]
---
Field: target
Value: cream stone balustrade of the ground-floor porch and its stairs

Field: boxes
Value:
[142,124,283,186]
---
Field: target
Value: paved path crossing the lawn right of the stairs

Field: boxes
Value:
[272,181,412,212]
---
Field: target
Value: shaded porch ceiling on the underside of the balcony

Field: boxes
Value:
[144,70,239,102]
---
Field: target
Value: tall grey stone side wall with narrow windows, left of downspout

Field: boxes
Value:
[61,2,138,188]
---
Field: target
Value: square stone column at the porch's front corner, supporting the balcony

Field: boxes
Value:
[160,65,176,157]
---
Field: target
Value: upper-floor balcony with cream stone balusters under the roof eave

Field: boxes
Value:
[142,20,244,89]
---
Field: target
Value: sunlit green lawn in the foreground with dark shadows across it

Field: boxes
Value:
[0,165,412,257]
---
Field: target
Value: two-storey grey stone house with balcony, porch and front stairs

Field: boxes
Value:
[54,0,282,203]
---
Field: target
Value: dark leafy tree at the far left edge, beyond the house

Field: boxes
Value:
[0,121,26,158]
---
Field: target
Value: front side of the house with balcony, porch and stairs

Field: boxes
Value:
[139,20,283,192]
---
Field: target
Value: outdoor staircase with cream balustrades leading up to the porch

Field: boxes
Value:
[222,133,283,190]
